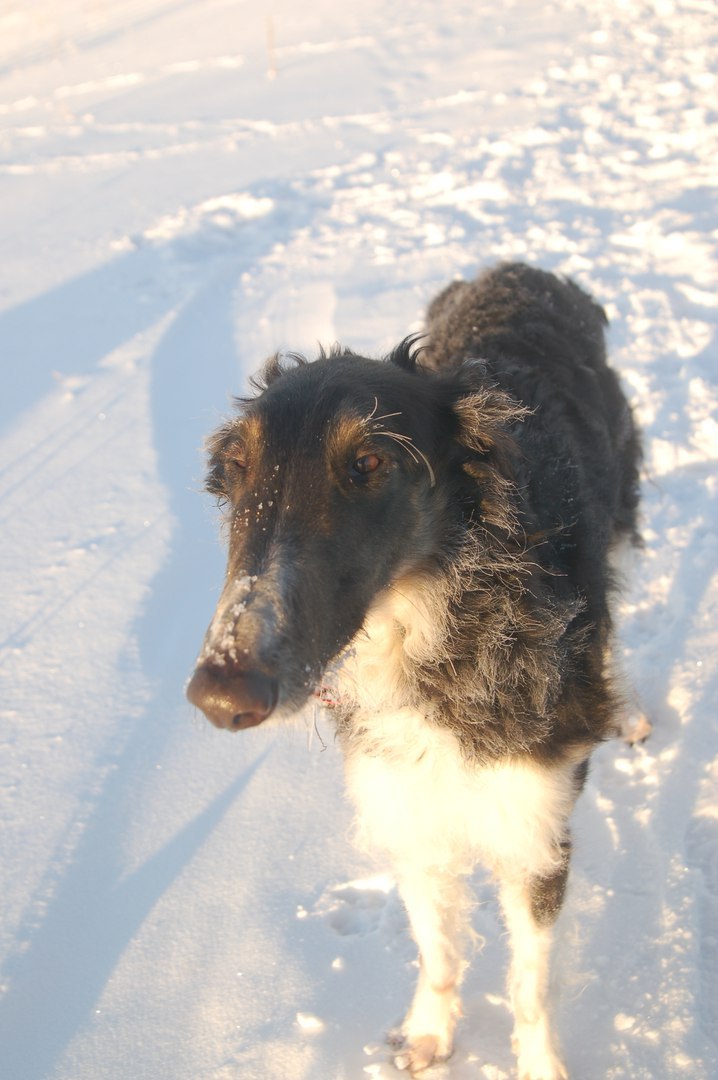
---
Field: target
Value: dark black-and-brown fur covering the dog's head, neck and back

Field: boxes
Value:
[188,265,639,762]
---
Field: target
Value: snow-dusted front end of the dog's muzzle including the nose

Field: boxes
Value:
[187,576,279,731]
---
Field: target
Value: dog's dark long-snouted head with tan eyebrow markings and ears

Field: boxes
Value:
[188,341,517,729]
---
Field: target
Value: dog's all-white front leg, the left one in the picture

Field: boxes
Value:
[394,868,470,1076]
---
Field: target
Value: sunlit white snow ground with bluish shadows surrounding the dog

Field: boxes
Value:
[0,0,718,1080]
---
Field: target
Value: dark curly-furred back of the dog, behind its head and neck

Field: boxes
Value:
[423,264,640,543]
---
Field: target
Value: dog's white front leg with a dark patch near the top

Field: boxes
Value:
[501,841,570,1080]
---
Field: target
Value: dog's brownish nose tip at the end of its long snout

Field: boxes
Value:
[187,666,279,731]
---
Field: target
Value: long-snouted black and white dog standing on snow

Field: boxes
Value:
[188,264,640,1080]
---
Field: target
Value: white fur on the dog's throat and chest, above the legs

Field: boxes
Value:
[336,577,574,876]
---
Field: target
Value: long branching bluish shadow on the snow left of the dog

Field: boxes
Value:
[0,187,317,1080]
